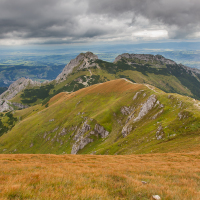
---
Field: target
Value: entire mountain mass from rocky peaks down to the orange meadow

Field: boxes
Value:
[0,52,200,154]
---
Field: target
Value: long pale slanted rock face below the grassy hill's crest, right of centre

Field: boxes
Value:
[133,94,157,122]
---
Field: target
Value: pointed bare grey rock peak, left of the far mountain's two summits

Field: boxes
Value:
[56,52,98,82]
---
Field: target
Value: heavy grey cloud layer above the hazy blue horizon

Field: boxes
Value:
[0,0,200,45]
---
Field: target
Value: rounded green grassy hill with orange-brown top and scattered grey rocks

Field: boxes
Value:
[0,79,200,154]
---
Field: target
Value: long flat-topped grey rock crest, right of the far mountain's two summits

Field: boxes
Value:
[114,53,176,65]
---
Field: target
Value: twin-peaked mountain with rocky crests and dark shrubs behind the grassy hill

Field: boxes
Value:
[8,52,200,110]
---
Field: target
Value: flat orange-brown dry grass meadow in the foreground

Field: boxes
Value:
[0,152,200,200]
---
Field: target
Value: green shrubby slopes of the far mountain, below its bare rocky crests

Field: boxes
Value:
[11,54,200,108]
